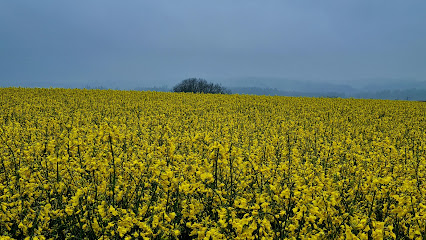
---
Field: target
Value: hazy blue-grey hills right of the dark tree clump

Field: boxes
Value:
[227,77,426,101]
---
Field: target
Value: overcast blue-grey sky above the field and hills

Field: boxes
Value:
[0,0,426,88]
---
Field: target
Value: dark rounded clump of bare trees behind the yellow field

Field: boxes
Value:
[173,78,231,94]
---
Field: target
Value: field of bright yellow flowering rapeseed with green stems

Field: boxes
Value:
[0,88,426,239]
